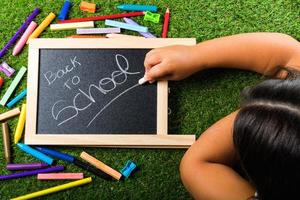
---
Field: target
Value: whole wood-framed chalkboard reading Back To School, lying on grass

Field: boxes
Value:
[24,38,196,148]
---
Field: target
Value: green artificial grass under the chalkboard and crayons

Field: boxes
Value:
[0,0,300,199]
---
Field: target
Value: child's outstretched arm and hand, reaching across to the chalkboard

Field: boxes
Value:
[145,33,300,80]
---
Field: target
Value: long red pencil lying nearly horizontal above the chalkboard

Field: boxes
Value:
[58,12,144,24]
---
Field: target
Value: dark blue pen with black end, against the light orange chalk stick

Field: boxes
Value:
[36,147,110,180]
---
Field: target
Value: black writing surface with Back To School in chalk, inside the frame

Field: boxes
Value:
[36,49,157,134]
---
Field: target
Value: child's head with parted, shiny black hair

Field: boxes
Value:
[233,80,300,200]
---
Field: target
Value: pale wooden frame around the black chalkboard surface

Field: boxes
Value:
[25,38,196,148]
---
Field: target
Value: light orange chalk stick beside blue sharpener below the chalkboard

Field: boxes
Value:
[80,151,122,180]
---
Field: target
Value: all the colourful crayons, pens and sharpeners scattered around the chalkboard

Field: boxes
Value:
[0,0,170,199]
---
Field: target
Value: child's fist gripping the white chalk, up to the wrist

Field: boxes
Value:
[144,45,196,83]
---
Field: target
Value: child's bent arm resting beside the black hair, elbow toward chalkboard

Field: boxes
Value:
[180,112,255,200]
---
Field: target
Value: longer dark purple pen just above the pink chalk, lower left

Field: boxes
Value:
[0,166,64,181]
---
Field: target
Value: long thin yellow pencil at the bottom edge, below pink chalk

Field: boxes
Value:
[11,177,92,200]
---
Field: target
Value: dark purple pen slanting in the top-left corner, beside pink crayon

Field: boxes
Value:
[0,8,41,58]
